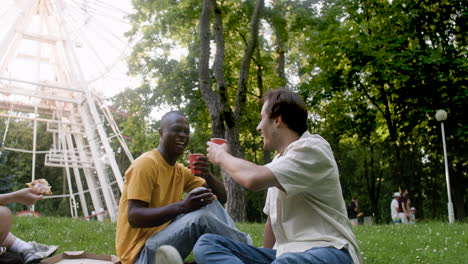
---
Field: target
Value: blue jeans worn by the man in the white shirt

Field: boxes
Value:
[193,234,353,264]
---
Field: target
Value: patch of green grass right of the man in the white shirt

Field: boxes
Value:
[355,222,468,264]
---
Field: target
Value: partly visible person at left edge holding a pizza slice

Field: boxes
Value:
[0,188,57,264]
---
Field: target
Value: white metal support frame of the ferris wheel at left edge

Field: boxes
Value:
[0,0,133,221]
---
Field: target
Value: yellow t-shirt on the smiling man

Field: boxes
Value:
[115,149,205,264]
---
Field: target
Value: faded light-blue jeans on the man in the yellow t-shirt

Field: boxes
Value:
[135,187,252,264]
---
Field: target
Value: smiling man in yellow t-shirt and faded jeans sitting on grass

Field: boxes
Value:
[115,111,251,264]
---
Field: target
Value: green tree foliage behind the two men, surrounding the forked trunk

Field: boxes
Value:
[119,0,468,222]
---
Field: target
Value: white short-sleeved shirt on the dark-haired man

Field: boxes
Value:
[263,131,361,264]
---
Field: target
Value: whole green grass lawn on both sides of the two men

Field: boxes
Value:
[12,217,468,264]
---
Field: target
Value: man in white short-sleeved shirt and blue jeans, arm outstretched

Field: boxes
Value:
[194,88,361,264]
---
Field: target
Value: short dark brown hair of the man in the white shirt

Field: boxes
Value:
[262,88,307,135]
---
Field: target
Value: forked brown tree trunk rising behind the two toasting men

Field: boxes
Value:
[199,0,264,221]
